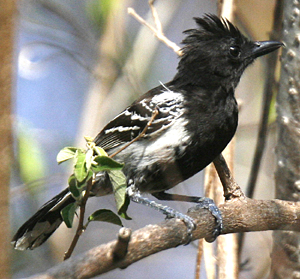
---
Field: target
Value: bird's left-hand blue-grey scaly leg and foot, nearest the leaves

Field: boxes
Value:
[127,185,196,244]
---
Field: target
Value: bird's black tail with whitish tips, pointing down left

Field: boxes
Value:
[12,188,75,250]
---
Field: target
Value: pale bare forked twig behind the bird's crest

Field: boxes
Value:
[127,6,182,56]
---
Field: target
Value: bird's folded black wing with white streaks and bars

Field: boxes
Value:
[94,85,184,152]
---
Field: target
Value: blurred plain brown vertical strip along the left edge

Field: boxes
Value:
[0,0,15,278]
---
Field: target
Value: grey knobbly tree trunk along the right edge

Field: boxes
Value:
[271,0,300,279]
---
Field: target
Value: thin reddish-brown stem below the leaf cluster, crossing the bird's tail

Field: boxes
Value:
[64,178,93,261]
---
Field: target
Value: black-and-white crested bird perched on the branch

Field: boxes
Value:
[12,14,283,250]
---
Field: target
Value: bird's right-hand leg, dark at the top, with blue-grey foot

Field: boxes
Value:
[152,191,223,241]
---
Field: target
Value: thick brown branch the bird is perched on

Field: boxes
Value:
[30,198,300,279]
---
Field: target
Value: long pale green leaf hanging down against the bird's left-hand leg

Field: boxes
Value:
[107,170,131,220]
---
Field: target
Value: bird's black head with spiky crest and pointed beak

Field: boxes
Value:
[175,15,283,88]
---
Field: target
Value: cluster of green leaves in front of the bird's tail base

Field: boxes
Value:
[57,137,130,232]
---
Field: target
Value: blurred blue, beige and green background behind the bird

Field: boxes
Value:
[11,0,275,279]
